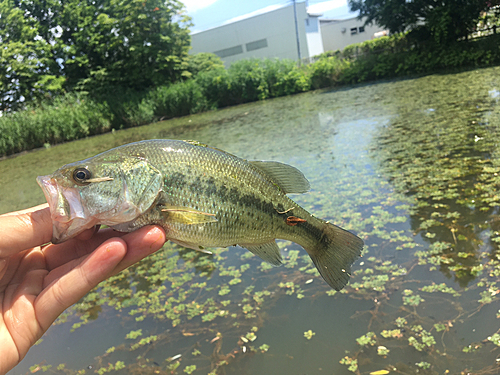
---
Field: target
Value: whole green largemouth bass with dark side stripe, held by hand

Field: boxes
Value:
[37,139,364,290]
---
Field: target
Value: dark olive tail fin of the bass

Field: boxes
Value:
[306,223,363,290]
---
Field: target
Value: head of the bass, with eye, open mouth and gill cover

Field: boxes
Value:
[37,154,161,243]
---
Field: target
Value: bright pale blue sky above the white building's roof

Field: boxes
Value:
[181,0,355,32]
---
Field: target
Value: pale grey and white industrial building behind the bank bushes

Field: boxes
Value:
[191,2,380,64]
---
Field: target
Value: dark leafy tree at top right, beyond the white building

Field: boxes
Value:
[349,0,500,44]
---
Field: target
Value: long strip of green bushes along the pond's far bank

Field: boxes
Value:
[0,34,500,155]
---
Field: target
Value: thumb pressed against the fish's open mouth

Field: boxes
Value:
[0,206,52,259]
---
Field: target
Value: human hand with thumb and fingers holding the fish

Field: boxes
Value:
[0,204,165,374]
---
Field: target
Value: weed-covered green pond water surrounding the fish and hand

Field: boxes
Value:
[0,68,500,375]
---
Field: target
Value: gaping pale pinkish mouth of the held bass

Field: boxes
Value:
[36,176,96,244]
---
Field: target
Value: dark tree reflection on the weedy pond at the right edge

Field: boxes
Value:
[376,76,500,287]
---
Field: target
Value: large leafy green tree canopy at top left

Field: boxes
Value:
[0,0,190,110]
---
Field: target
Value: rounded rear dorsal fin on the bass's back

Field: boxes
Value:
[249,161,310,194]
